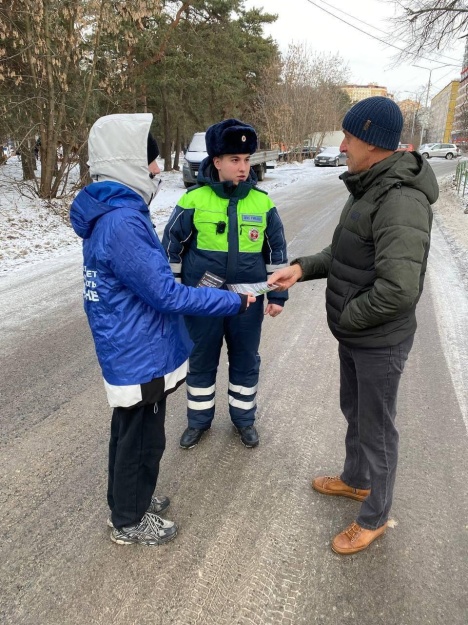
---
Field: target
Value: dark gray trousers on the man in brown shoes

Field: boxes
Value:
[338,335,414,529]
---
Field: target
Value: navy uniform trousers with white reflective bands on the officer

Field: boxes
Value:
[185,296,264,430]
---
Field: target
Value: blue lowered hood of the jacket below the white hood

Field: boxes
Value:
[70,181,149,239]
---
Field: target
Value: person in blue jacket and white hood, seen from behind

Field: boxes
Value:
[70,113,255,545]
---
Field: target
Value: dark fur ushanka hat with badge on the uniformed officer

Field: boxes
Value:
[205,119,257,158]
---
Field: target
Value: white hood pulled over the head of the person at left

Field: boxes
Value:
[88,113,156,204]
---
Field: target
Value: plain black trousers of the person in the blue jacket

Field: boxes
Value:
[107,398,166,528]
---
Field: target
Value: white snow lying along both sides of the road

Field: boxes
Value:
[0,157,468,432]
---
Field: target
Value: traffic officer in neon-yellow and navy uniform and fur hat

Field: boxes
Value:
[162,119,287,449]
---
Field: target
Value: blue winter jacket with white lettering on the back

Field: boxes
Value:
[70,181,245,386]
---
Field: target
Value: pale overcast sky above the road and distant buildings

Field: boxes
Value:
[246,0,464,102]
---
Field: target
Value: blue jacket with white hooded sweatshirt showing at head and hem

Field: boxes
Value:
[70,114,245,407]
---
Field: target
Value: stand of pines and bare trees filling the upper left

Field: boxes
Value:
[0,0,277,193]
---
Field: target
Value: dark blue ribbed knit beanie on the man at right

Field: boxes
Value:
[343,96,403,150]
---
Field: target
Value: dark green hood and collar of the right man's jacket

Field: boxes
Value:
[340,152,439,204]
